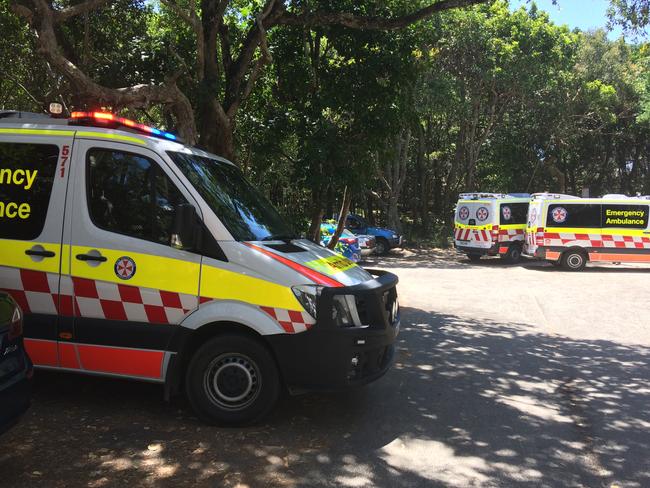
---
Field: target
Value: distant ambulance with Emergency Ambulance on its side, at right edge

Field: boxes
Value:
[525,193,650,271]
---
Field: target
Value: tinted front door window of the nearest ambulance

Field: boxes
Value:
[88,149,187,245]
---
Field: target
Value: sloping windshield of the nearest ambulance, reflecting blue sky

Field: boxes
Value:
[168,151,296,241]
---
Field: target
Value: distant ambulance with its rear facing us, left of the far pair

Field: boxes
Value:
[454,193,530,263]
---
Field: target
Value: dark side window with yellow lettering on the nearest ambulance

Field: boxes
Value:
[0,142,59,240]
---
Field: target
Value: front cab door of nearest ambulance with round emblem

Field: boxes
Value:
[69,140,201,381]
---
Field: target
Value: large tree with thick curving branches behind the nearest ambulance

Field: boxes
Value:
[12,0,485,159]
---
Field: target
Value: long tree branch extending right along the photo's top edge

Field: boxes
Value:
[276,0,487,31]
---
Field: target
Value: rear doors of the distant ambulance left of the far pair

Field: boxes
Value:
[454,200,498,249]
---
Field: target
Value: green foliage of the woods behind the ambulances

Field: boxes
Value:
[5,0,650,245]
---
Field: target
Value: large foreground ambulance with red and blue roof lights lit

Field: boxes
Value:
[0,112,400,424]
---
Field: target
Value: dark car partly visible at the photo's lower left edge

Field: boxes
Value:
[0,292,33,433]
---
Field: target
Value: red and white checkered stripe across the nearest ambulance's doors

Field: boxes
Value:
[0,267,198,324]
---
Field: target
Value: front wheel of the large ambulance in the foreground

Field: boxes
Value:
[185,334,280,425]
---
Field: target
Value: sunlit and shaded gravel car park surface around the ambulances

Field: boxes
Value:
[0,250,650,488]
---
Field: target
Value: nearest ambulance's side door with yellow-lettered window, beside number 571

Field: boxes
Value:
[0,128,74,367]
